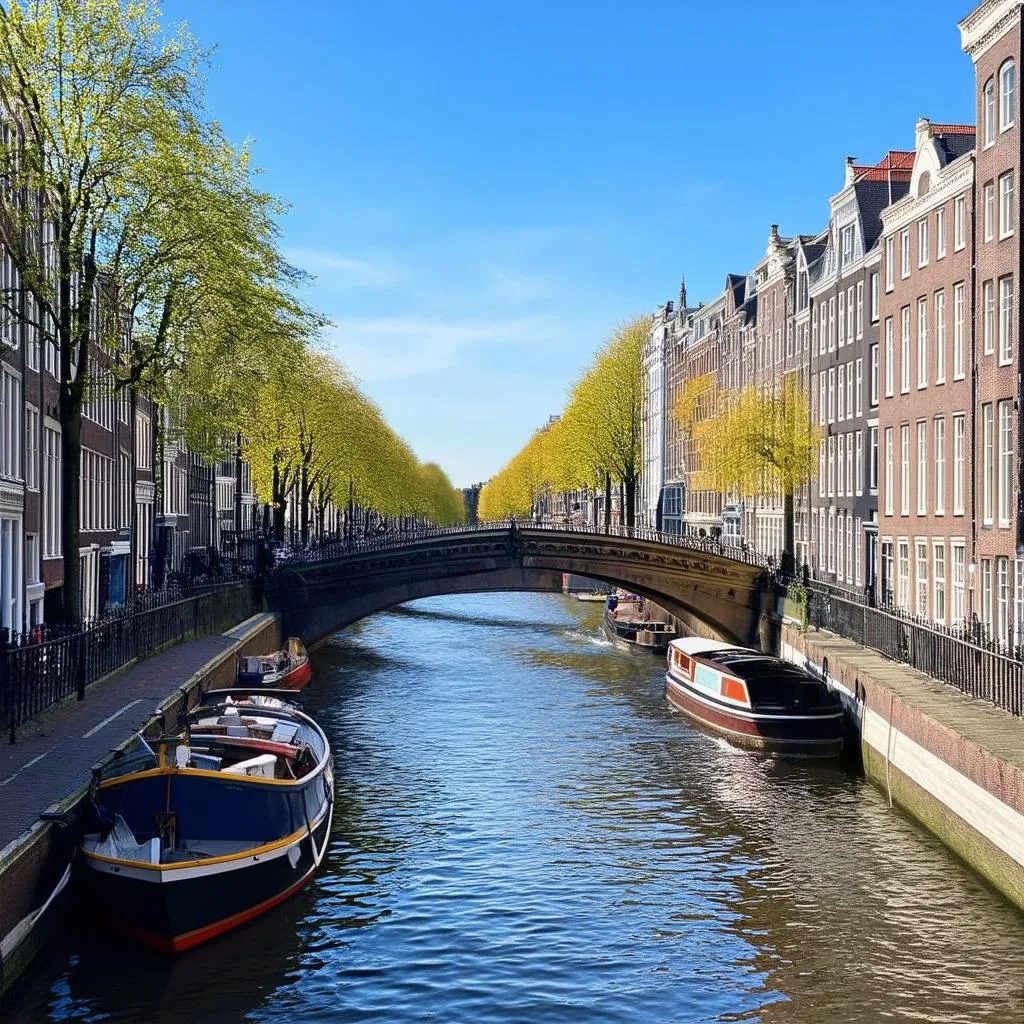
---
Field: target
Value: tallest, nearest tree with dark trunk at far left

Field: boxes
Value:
[0,0,207,620]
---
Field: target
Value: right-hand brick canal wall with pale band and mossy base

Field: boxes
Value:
[781,626,1024,909]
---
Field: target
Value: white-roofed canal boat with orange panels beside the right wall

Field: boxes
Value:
[665,637,843,757]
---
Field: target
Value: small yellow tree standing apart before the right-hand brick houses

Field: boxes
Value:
[673,374,820,571]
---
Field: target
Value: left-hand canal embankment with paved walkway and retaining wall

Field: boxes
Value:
[0,612,281,996]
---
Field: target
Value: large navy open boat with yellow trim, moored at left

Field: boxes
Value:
[81,690,334,952]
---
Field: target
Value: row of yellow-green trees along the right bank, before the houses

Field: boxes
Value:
[480,317,820,569]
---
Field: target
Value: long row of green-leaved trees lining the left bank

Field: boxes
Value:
[0,0,455,618]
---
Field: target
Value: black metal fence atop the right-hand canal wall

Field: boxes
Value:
[808,582,1024,716]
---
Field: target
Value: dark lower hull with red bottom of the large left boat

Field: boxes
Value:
[83,802,334,953]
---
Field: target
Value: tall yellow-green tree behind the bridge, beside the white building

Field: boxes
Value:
[563,316,650,527]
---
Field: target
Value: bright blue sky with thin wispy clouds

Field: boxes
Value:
[164,0,974,485]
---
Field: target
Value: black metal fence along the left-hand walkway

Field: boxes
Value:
[0,581,259,742]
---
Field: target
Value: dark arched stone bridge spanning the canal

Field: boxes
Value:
[266,526,777,649]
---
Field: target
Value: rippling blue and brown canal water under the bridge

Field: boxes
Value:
[6,594,1024,1024]
